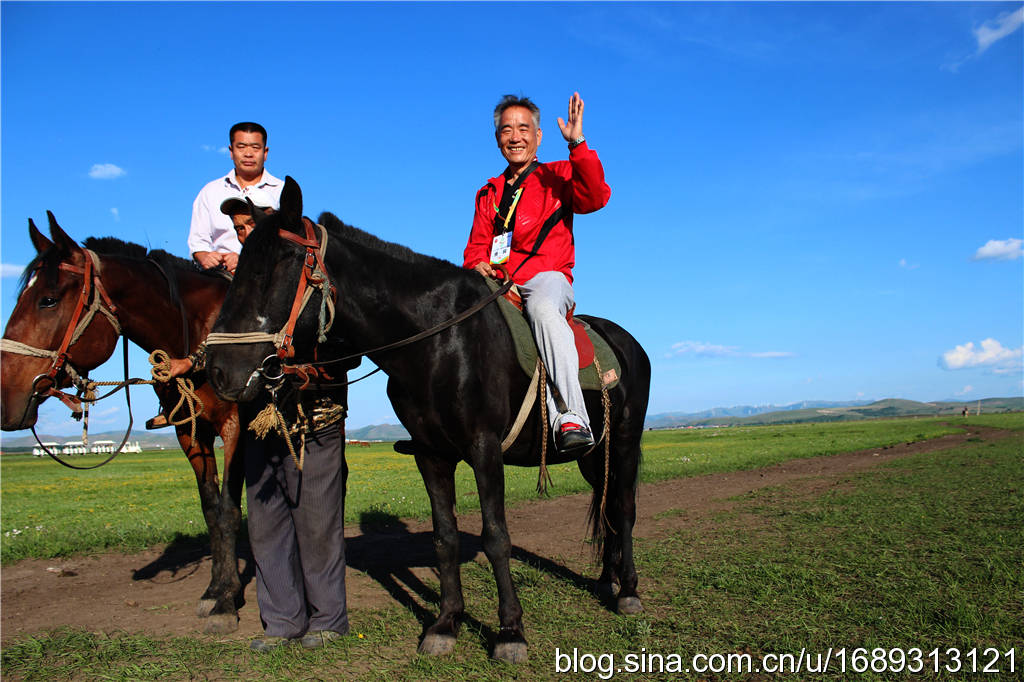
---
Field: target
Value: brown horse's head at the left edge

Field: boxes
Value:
[0,211,119,431]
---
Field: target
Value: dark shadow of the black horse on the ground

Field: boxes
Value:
[345,511,614,643]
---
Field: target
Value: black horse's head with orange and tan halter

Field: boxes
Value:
[207,176,333,401]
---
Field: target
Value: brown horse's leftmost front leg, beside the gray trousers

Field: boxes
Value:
[175,421,238,632]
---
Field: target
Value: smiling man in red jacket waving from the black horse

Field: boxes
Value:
[463,92,611,452]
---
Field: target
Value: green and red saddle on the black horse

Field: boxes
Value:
[484,278,622,391]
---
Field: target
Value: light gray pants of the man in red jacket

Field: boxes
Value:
[519,270,590,429]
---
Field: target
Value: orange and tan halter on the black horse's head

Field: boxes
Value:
[206,218,337,365]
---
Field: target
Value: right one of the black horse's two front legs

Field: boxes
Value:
[473,441,526,664]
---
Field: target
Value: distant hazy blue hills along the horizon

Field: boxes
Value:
[0,397,1024,452]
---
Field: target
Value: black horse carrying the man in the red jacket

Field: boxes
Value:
[208,177,650,663]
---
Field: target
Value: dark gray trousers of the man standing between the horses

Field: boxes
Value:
[246,422,348,638]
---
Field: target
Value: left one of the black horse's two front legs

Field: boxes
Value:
[416,452,465,656]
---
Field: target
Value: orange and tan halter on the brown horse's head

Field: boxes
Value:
[0,249,121,405]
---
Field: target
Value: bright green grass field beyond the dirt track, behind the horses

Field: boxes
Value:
[0,415,974,564]
